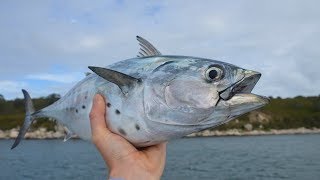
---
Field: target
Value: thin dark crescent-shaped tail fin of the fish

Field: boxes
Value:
[11,89,34,149]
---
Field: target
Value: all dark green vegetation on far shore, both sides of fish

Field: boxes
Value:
[0,94,320,130]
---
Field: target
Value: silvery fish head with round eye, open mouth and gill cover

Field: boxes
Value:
[146,57,267,126]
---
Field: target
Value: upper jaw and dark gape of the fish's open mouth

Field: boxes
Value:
[219,70,261,101]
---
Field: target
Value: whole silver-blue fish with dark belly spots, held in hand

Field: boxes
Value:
[11,36,269,149]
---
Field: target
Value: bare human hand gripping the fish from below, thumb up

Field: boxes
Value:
[90,94,166,180]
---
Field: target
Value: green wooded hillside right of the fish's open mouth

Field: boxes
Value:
[218,96,320,130]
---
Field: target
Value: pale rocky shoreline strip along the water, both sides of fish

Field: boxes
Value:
[0,127,320,139]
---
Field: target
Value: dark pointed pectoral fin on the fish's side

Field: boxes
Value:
[89,66,141,95]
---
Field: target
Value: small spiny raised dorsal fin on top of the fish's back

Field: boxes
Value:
[137,36,161,57]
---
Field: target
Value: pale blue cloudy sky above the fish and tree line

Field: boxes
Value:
[0,0,320,99]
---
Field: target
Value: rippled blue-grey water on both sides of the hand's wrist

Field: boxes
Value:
[0,134,320,180]
